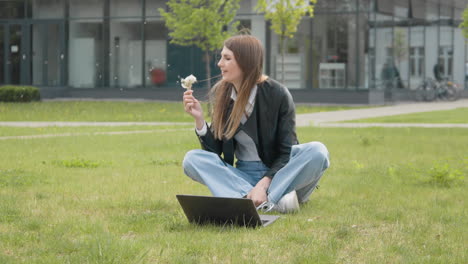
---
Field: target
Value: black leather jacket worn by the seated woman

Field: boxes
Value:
[198,78,298,178]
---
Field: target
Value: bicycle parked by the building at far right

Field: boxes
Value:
[415,78,460,101]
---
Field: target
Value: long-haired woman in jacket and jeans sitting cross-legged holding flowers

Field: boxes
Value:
[183,35,330,213]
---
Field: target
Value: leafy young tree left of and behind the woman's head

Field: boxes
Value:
[158,0,240,88]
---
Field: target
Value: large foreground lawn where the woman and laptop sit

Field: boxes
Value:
[0,127,468,263]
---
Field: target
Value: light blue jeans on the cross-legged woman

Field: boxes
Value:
[183,142,330,204]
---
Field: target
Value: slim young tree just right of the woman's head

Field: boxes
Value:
[255,0,317,82]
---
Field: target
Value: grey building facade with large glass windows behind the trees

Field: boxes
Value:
[0,0,468,98]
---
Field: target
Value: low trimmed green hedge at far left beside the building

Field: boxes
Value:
[0,85,41,102]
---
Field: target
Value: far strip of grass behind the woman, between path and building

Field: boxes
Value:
[0,101,366,122]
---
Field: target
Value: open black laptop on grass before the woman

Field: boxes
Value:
[176,194,279,227]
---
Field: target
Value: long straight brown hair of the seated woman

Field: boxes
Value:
[210,35,264,139]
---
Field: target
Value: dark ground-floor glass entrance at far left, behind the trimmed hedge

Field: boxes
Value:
[0,21,65,86]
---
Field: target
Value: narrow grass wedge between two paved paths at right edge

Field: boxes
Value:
[347,108,468,124]
